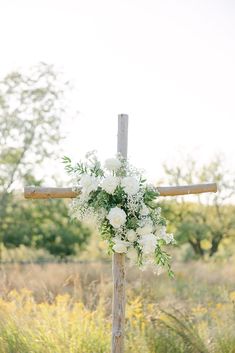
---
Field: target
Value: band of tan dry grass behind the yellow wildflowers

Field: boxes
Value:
[0,260,235,306]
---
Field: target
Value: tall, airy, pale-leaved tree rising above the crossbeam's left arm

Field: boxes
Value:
[0,63,66,212]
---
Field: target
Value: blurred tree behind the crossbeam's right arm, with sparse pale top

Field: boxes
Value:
[161,156,235,257]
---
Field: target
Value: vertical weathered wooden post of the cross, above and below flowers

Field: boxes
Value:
[112,114,128,353]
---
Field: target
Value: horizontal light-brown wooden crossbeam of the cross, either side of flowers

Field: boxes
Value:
[24,183,217,199]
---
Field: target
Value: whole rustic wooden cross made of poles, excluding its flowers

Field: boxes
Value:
[24,114,217,353]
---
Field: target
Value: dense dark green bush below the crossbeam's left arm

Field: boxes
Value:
[2,196,90,259]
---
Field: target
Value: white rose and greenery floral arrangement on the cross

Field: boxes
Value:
[63,152,174,276]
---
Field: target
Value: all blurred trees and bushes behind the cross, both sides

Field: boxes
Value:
[0,63,235,260]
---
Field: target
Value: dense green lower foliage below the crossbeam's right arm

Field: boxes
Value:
[162,201,235,257]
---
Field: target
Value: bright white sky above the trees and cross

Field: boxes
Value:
[0,0,235,183]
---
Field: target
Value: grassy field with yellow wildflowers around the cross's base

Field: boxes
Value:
[0,259,235,353]
